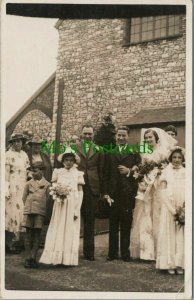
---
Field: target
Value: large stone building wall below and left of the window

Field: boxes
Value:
[52,16,186,140]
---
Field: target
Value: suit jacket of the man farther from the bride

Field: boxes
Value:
[76,142,104,195]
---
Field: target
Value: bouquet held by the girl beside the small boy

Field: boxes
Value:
[49,183,71,203]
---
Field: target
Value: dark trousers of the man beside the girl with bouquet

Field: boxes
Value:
[81,185,98,257]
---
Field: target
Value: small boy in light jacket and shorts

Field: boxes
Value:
[22,161,50,268]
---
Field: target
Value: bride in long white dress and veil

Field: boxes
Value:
[130,128,177,260]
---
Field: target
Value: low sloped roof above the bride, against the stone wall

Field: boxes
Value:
[125,106,185,125]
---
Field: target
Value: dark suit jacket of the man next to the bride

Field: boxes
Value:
[103,149,141,208]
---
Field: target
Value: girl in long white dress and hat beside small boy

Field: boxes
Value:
[40,148,84,266]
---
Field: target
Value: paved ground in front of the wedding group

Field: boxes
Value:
[5,233,184,293]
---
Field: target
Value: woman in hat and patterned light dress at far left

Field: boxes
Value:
[5,133,30,253]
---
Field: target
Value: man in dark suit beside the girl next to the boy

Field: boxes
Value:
[76,125,104,261]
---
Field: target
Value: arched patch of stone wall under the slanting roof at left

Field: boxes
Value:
[14,109,52,141]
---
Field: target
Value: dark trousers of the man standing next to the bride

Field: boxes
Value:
[108,204,132,259]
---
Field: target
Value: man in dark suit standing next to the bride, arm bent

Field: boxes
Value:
[103,126,141,261]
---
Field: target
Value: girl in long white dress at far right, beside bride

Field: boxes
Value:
[156,147,185,274]
